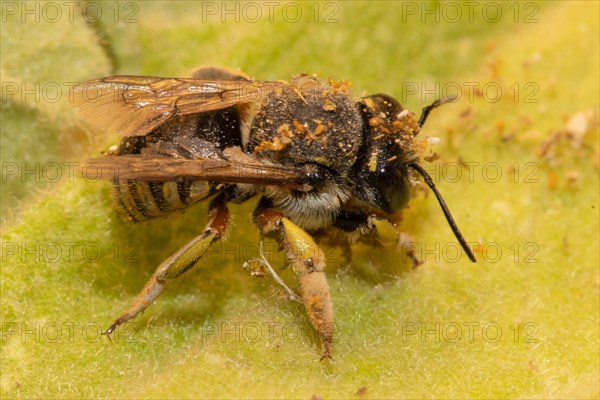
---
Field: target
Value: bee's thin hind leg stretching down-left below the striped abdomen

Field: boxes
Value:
[104,196,230,336]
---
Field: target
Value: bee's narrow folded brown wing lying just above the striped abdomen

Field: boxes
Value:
[81,150,312,191]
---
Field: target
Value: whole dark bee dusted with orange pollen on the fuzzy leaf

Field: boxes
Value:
[74,66,475,359]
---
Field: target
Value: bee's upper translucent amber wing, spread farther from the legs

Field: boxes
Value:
[72,75,283,136]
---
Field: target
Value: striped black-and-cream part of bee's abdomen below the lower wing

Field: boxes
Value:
[114,180,214,222]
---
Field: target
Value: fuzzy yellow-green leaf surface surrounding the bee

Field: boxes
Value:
[0,1,600,399]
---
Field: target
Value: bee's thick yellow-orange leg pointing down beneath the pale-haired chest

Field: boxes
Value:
[254,201,334,359]
